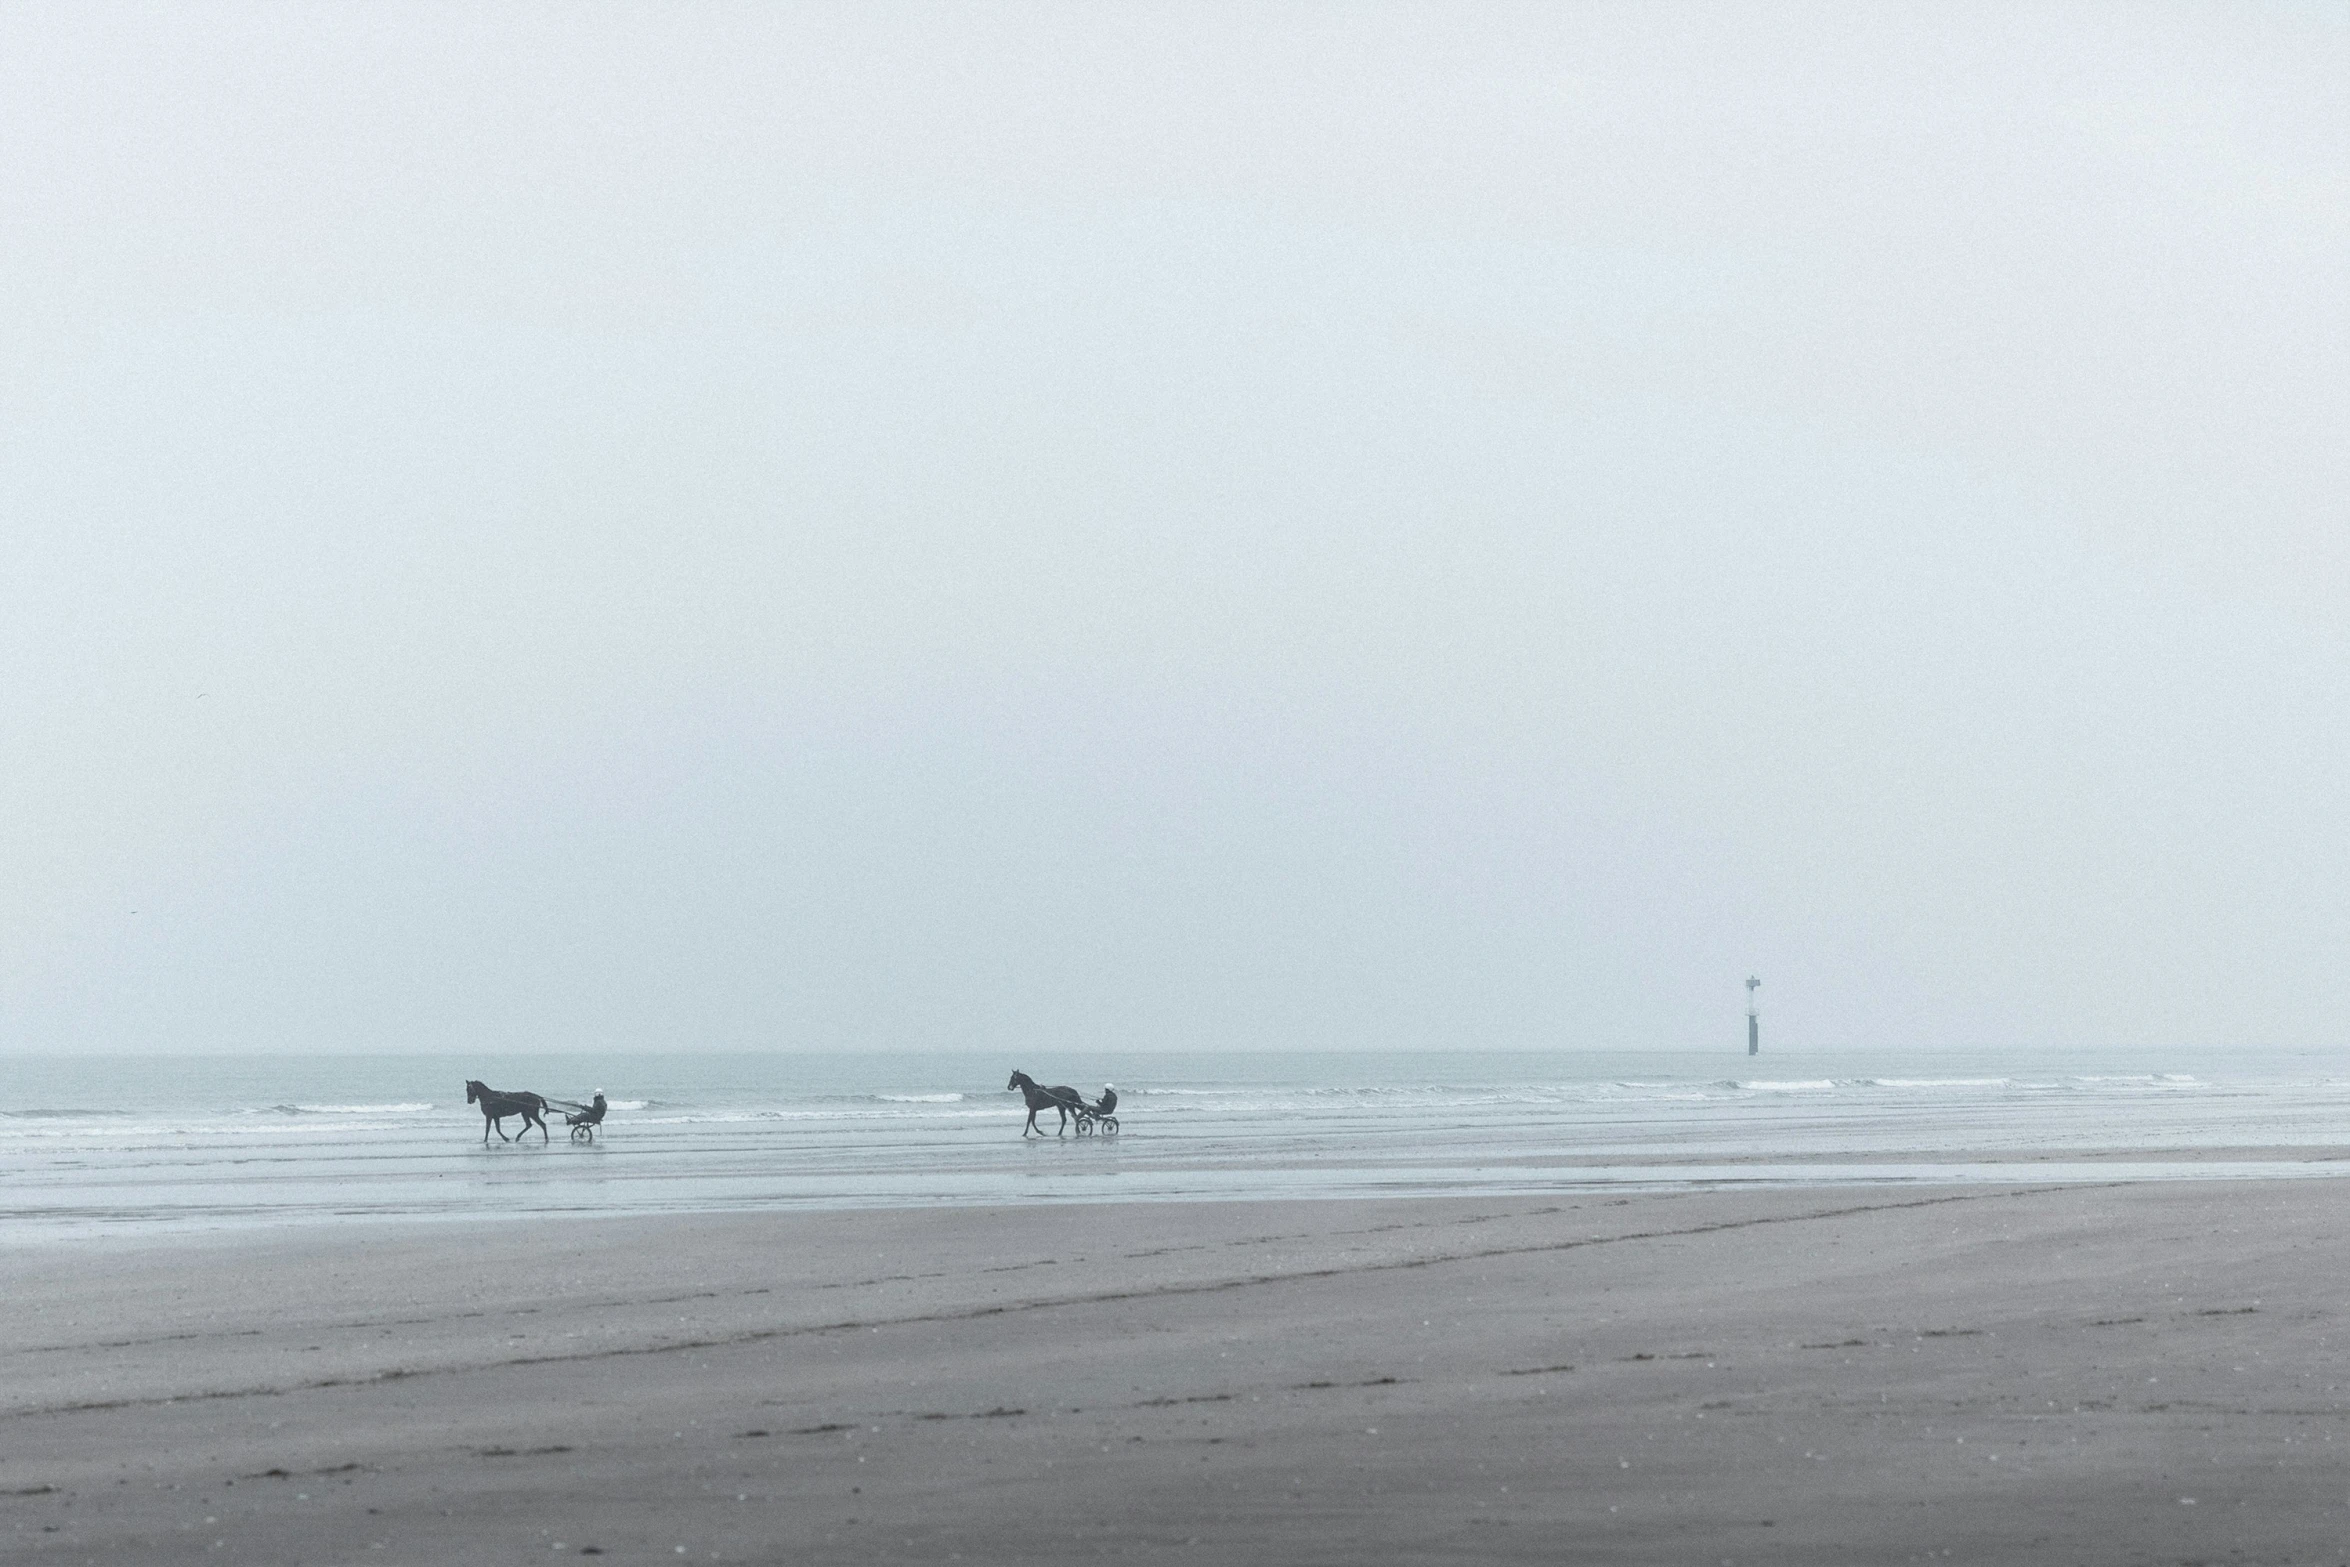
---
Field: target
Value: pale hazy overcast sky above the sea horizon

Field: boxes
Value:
[0,0,2350,1052]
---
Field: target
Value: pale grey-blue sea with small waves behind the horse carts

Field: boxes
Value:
[0,1050,2350,1243]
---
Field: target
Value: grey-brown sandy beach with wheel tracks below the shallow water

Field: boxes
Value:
[0,1170,2350,1565]
